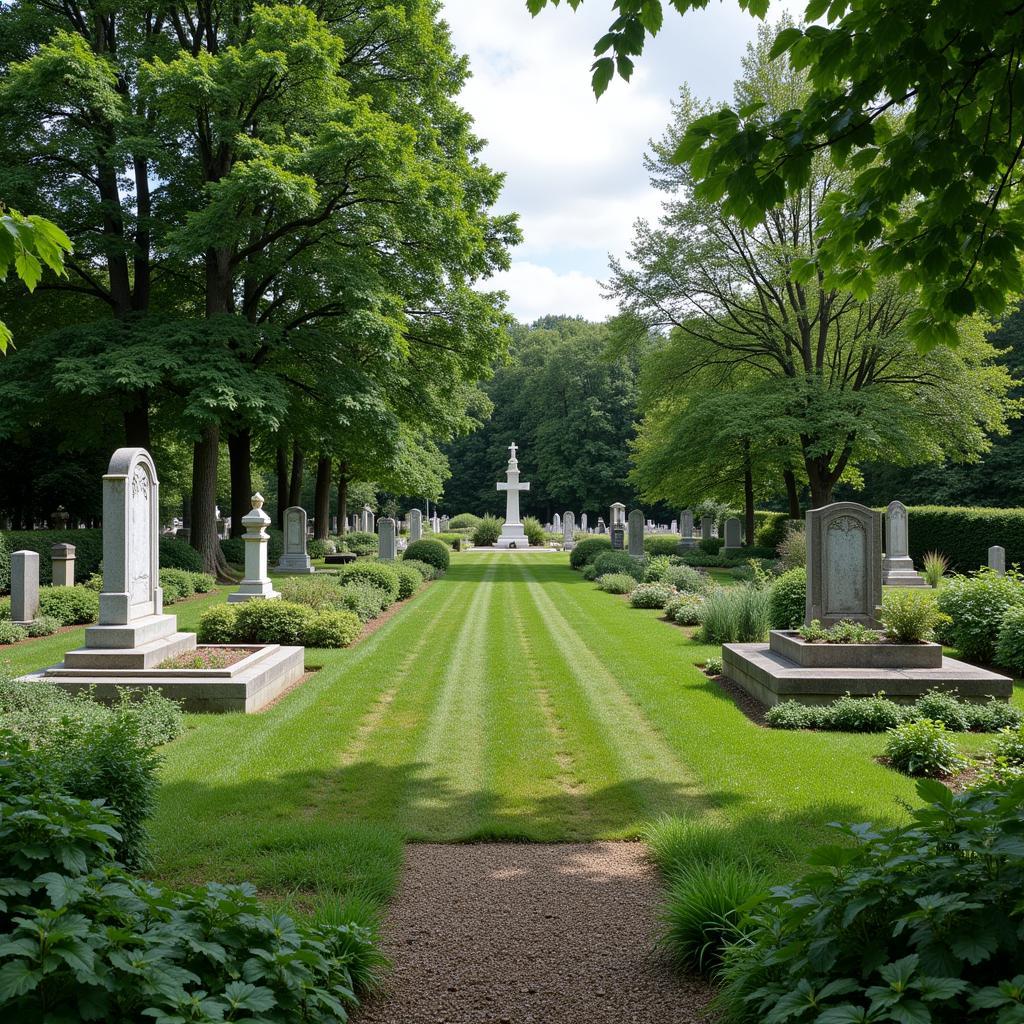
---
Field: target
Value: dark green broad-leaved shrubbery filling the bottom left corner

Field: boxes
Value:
[0,733,379,1024]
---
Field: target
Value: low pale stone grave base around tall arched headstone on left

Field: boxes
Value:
[20,634,305,712]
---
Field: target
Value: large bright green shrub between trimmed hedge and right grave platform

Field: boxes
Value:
[936,568,1024,664]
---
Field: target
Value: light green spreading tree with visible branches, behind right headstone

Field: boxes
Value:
[610,29,1018,507]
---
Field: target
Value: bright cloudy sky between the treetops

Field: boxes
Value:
[443,0,802,323]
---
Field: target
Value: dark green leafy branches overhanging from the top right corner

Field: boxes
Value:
[526,0,1024,347]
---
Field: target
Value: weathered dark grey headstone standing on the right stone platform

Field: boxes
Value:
[806,502,882,629]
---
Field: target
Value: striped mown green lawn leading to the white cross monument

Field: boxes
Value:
[130,553,1024,918]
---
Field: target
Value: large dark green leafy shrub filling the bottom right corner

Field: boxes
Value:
[717,780,1024,1024]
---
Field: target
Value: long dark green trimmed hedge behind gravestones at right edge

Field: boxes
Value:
[907,505,1024,572]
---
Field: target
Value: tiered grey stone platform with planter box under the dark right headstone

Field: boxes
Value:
[722,630,1013,708]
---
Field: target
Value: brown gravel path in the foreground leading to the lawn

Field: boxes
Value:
[356,843,710,1024]
